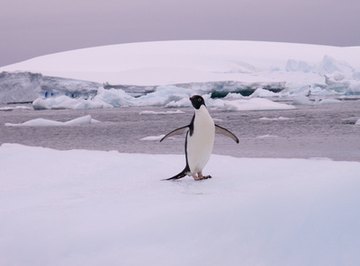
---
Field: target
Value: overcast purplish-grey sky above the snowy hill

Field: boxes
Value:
[0,0,360,66]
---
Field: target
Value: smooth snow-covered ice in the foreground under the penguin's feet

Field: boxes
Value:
[0,144,360,266]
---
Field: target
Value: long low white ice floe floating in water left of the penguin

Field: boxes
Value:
[5,115,99,127]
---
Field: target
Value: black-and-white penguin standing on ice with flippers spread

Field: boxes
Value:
[160,95,239,180]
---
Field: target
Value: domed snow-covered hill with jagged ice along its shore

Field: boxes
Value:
[0,41,360,110]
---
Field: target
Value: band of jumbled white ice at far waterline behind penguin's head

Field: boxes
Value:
[33,86,294,112]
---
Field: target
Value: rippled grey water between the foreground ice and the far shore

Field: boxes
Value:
[0,101,360,161]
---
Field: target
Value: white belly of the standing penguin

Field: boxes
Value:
[187,107,215,174]
